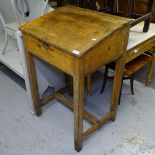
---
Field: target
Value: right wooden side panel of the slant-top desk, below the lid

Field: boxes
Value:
[84,27,129,74]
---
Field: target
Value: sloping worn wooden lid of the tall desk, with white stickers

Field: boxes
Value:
[20,6,131,57]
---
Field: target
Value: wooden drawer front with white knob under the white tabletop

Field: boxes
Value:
[126,37,155,63]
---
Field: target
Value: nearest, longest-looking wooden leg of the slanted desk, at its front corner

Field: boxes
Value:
[73,60,84,152]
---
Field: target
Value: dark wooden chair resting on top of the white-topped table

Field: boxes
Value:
[98,0,154,32]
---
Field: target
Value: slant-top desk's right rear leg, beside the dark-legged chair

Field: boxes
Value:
[110,54,125,121]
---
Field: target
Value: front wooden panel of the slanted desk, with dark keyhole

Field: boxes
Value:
[23,34,74,75]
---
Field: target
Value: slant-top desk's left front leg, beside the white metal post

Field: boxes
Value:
[26,52,41,116]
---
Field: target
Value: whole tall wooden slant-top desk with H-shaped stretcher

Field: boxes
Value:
[20,6,130,151]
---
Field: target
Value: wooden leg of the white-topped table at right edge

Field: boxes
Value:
[146,48,155,86]
